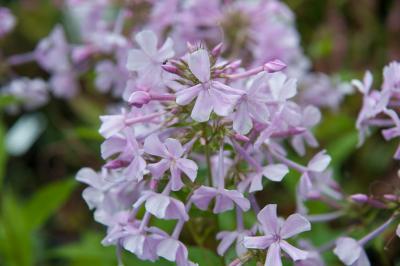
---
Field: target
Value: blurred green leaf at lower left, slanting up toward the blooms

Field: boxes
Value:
[24,178,77,230]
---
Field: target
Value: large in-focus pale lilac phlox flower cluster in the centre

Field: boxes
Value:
[77,24,340,265]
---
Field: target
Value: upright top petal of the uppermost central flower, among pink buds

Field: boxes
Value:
[188,49,211,83]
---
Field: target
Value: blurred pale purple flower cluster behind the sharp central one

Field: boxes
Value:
[0,0,347,114]
